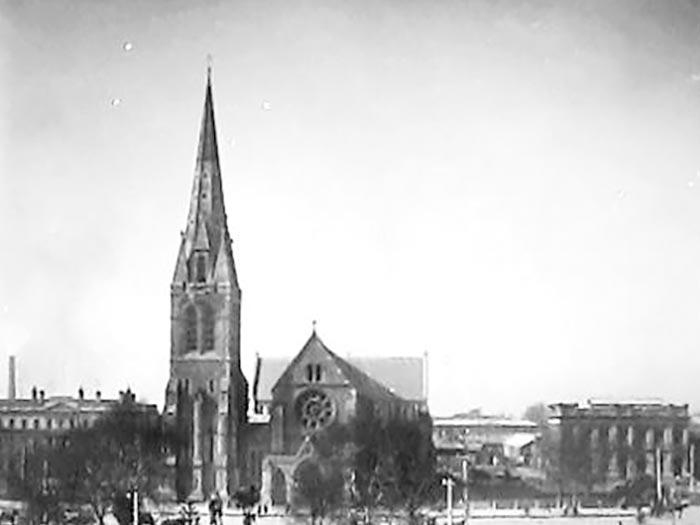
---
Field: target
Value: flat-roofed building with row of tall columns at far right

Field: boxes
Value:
[550,400,690,490]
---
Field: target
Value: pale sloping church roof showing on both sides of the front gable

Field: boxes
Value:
[253,344,425,402]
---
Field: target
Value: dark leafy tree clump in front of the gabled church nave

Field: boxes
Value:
[297,410,439,521]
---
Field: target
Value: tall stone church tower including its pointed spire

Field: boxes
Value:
[165,71,248,500]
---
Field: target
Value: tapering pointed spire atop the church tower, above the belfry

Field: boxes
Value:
[175,70,235,282]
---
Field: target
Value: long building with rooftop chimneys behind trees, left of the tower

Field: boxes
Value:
[0,356,158,496]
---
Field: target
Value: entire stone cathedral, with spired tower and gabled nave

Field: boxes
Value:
[164,74,427,504]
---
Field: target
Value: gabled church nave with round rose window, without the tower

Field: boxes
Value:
[251,328,427,505]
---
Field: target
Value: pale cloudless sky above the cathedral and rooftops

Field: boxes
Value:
[0,0,700,416]
